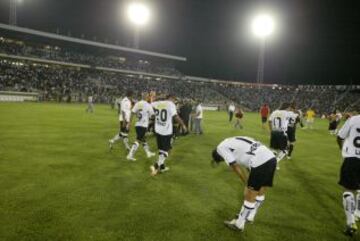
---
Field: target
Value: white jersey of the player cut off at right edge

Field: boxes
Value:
[338,115,360,158]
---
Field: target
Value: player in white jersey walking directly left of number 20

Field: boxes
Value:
[126,95,155,161]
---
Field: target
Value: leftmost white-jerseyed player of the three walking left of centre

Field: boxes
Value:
[109,90,133,151]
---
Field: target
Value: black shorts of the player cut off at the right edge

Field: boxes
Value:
[339,157,360,191]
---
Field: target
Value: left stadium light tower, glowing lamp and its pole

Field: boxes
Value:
[127,1,150,49]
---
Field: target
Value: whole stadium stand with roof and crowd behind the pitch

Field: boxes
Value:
[0,25,360,114]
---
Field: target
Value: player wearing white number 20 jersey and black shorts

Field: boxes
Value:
[150,95,187,176]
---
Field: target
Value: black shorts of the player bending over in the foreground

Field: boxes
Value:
[248,158,277,191]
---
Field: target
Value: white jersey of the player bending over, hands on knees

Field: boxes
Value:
[217,136,275,169]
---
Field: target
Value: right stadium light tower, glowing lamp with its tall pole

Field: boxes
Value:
[251,14,275,87]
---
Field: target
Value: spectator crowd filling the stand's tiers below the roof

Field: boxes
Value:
[0,35,360,114]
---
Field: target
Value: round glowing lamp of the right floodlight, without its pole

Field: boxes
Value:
[251,14,275,38]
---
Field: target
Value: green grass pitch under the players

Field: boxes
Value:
[0,103,360,241]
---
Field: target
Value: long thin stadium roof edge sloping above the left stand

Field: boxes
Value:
[0,23,187,61]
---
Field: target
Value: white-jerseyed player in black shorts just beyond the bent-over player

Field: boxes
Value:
[269,103,289,162]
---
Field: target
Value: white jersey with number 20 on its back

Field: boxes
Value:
[151,100,177,136]
